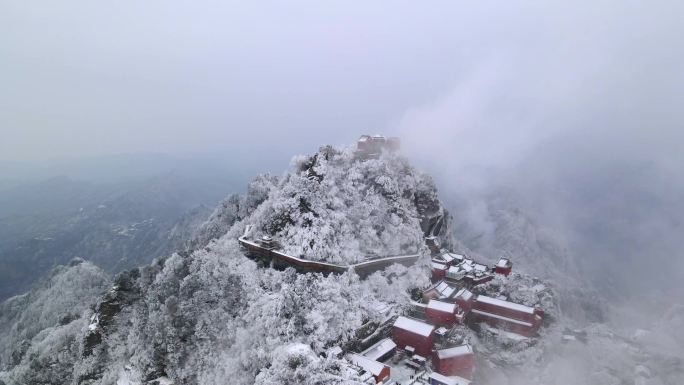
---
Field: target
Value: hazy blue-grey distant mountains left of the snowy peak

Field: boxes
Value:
[0,156,246,299]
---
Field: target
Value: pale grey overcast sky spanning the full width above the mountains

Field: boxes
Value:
[0,0,683,164]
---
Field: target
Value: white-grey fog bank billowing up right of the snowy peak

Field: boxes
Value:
[394,2,684,299]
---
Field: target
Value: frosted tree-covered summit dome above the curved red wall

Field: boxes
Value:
[228,146,444,264]
